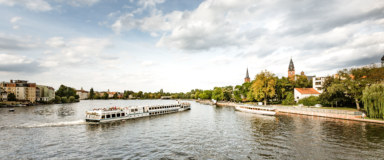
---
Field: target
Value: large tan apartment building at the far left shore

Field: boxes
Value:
[0,80,36,103]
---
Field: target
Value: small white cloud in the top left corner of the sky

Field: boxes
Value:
[0,0,52,12]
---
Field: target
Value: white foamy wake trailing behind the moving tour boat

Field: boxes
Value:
[0,120,87,128]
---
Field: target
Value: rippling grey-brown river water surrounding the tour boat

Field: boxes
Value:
[0,100,384,159]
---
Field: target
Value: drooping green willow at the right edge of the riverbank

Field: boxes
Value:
[362,84,384,119]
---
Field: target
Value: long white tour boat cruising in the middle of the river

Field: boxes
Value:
[85,103,191,122]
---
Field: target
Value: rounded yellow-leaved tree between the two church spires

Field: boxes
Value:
[251,71,276,105]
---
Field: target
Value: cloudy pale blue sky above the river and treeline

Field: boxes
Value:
[0,0,384,92]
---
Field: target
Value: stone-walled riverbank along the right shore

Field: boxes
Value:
[197,100,384,124]
